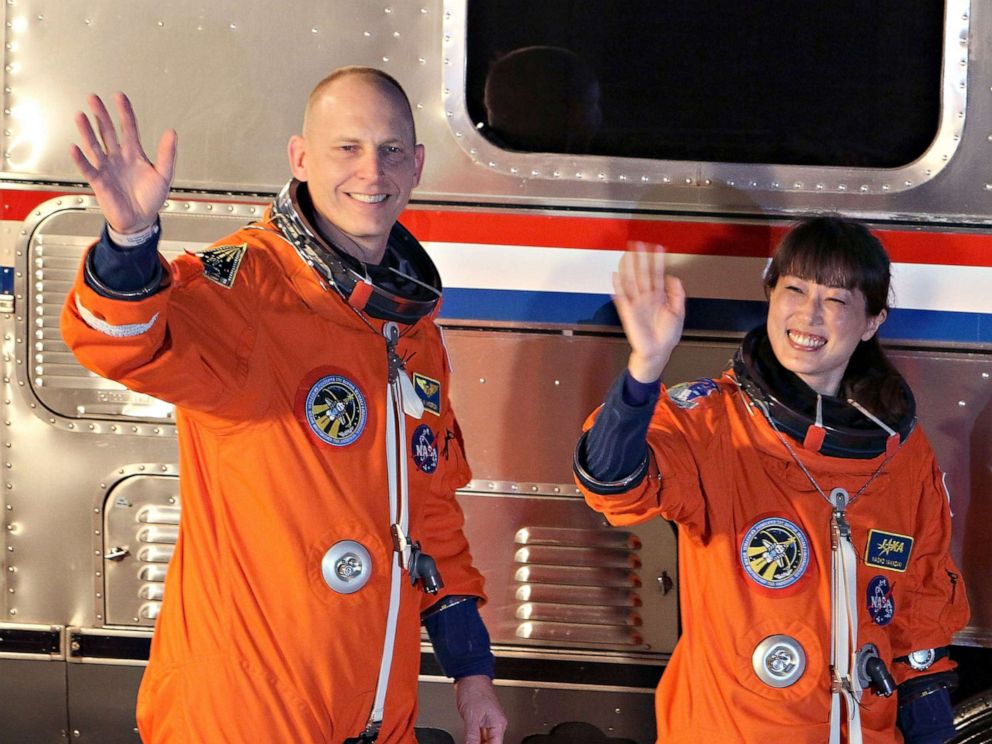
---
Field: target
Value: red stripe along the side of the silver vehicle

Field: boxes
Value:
[0,189,992,267]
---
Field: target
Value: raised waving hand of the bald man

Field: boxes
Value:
[69,93,176,233]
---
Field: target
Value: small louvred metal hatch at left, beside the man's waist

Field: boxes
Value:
[104,475,180,626]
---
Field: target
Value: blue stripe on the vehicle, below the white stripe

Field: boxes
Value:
[441,287,992,343]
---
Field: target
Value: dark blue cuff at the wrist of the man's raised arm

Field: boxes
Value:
[85,226,163,300]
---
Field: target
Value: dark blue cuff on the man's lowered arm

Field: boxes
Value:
[423,597,496,679]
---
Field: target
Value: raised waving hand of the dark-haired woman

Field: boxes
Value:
[613,242,685,382]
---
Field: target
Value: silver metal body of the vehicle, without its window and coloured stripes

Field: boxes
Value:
[0,0,992,744]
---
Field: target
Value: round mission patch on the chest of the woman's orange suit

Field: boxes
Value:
[740,517,810,589]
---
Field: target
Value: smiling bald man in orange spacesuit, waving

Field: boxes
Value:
[62,67,506,744]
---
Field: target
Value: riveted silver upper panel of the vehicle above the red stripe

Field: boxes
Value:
[3,0,992,221]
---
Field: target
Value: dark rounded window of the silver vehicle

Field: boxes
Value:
[466,0,944,168]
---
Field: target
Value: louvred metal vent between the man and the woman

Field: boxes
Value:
[514,526,644,646]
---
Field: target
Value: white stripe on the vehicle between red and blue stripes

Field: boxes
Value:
[424,242,992,313]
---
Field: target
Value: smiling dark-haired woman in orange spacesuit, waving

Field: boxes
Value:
[575,216,968,744]
